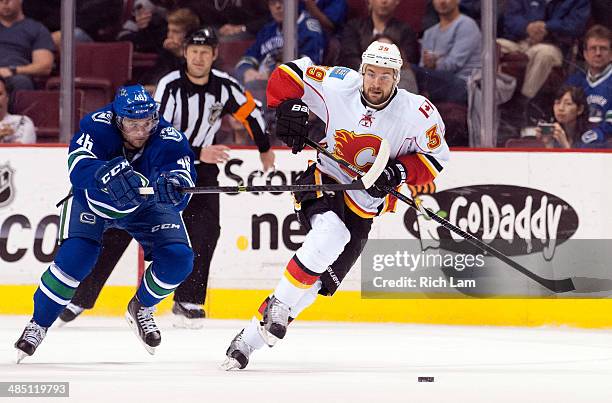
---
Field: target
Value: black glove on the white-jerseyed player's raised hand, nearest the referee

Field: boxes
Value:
[276,99,308,154]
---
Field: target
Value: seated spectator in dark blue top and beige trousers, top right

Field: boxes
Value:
[497,0,590,119]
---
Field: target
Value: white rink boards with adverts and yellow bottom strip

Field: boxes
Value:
[0,146,612,327]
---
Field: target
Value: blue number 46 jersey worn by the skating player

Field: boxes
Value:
[68,104,196,219]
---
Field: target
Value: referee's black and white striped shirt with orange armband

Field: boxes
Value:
[155,68,270,158]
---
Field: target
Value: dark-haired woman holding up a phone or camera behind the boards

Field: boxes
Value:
[535,86,591,148]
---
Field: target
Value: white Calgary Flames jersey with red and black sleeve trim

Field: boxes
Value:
[267,57,449,218]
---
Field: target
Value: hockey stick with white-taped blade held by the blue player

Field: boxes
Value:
[139,140,390,195]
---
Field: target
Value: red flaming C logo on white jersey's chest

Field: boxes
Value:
[334,129,381,177]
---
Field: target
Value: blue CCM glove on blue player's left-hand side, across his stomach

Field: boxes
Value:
[94,157,145,207]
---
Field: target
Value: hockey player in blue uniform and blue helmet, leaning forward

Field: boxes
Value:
[15,85,195,362]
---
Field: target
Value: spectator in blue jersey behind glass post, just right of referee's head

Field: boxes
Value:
[236,0,325,84]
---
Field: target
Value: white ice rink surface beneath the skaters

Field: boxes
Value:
[0,316,612,403]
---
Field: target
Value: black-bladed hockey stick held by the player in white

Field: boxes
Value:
[306,139,592,293]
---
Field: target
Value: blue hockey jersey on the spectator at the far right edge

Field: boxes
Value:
[567,64,612,148]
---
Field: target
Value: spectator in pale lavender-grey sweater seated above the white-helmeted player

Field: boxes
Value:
[414,0,482,104]
